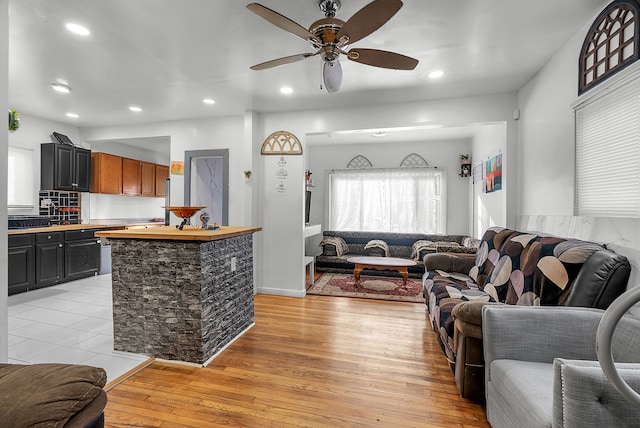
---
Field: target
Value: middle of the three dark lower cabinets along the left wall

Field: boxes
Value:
[35,232,64,288]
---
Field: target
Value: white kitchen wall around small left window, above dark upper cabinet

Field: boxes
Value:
[4,113,81,215]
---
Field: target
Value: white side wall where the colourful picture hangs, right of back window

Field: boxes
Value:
[471,123,508,238]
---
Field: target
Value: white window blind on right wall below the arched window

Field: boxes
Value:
[575,77,640,217]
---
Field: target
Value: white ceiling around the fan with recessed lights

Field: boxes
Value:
[9,0,607,127]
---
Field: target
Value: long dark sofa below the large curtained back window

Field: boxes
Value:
[316,230,479,278]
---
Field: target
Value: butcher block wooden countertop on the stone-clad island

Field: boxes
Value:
[96,225,262,241]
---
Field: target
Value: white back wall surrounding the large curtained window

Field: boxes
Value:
[307,137,471,235]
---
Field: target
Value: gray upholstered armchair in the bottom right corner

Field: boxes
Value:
[482,305,640,428]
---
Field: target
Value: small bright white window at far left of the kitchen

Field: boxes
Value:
[7,147,36,208]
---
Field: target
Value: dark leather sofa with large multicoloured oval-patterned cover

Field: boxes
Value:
[423,228,631,401]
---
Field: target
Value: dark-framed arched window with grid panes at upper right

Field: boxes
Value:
[578,0,640,94]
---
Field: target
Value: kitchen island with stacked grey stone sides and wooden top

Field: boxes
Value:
[96,226,262,364]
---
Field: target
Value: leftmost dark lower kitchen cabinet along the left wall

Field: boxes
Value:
[7,234,35,295]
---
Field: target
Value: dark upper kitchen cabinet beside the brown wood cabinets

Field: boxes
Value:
[40,143,91,192]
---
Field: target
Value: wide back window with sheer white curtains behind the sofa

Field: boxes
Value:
[329,168,447,233]
